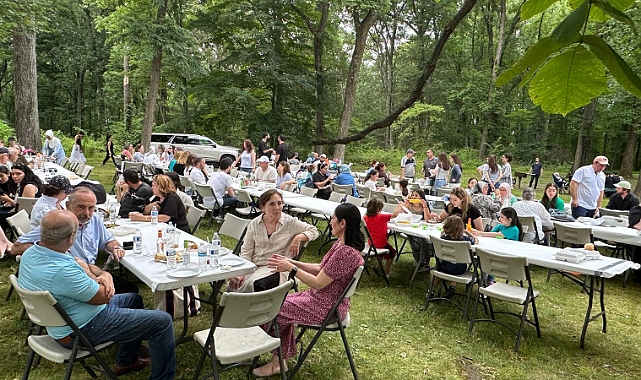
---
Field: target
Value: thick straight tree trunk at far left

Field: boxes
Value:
[13,27,42,152]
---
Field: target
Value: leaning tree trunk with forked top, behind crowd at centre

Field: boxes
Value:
[334,10,377,161]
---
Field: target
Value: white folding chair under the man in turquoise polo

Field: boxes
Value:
[9,275,118,380]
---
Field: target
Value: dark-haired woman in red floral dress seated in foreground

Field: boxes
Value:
[253,203,365,377]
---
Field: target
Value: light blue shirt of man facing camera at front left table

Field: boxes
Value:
[18,214,116,264]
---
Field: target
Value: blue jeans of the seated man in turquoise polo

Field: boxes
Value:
[67,293,176,380]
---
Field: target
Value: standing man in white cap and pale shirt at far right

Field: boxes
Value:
[570,156,608,218]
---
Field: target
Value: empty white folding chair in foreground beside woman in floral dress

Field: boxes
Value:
[189,280,293,380]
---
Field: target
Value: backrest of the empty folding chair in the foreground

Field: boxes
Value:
[218,280,294,328]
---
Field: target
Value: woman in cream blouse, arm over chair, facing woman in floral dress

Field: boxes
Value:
[229,189,318,293]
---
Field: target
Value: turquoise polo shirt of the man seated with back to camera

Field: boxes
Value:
[18,244,106,339]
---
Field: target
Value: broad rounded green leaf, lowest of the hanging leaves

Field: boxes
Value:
[528,45,607,116]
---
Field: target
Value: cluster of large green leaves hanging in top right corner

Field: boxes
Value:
[496,0,641,116]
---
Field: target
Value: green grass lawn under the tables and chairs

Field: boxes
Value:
[0,157,641,379]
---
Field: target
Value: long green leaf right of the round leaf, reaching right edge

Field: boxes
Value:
[583,35,641,98]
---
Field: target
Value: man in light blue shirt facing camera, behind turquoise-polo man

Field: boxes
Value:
[11,186,138,294]
